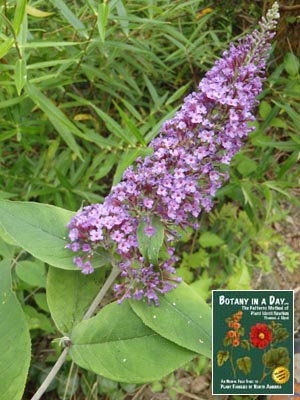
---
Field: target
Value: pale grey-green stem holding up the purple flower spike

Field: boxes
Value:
[31,260,121,400]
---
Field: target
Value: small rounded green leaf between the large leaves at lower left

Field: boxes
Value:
[16,260,46,288]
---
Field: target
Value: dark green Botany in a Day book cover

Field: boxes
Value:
[212,290,294,395]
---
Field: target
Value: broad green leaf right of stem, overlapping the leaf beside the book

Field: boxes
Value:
[70,302,195,383]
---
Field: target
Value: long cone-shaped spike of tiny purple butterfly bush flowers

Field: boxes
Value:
[67,3,279,305]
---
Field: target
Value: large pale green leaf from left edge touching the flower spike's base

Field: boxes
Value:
[0,200,77,269]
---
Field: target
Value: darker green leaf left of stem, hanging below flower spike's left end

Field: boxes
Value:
[47,267,104,335]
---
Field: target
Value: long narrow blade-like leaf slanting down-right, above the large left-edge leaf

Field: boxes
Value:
[26,83,82,159]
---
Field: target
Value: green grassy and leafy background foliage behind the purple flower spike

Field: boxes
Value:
[0,0,300,399]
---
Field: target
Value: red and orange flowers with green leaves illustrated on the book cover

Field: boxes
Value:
[217,318,290,383]
